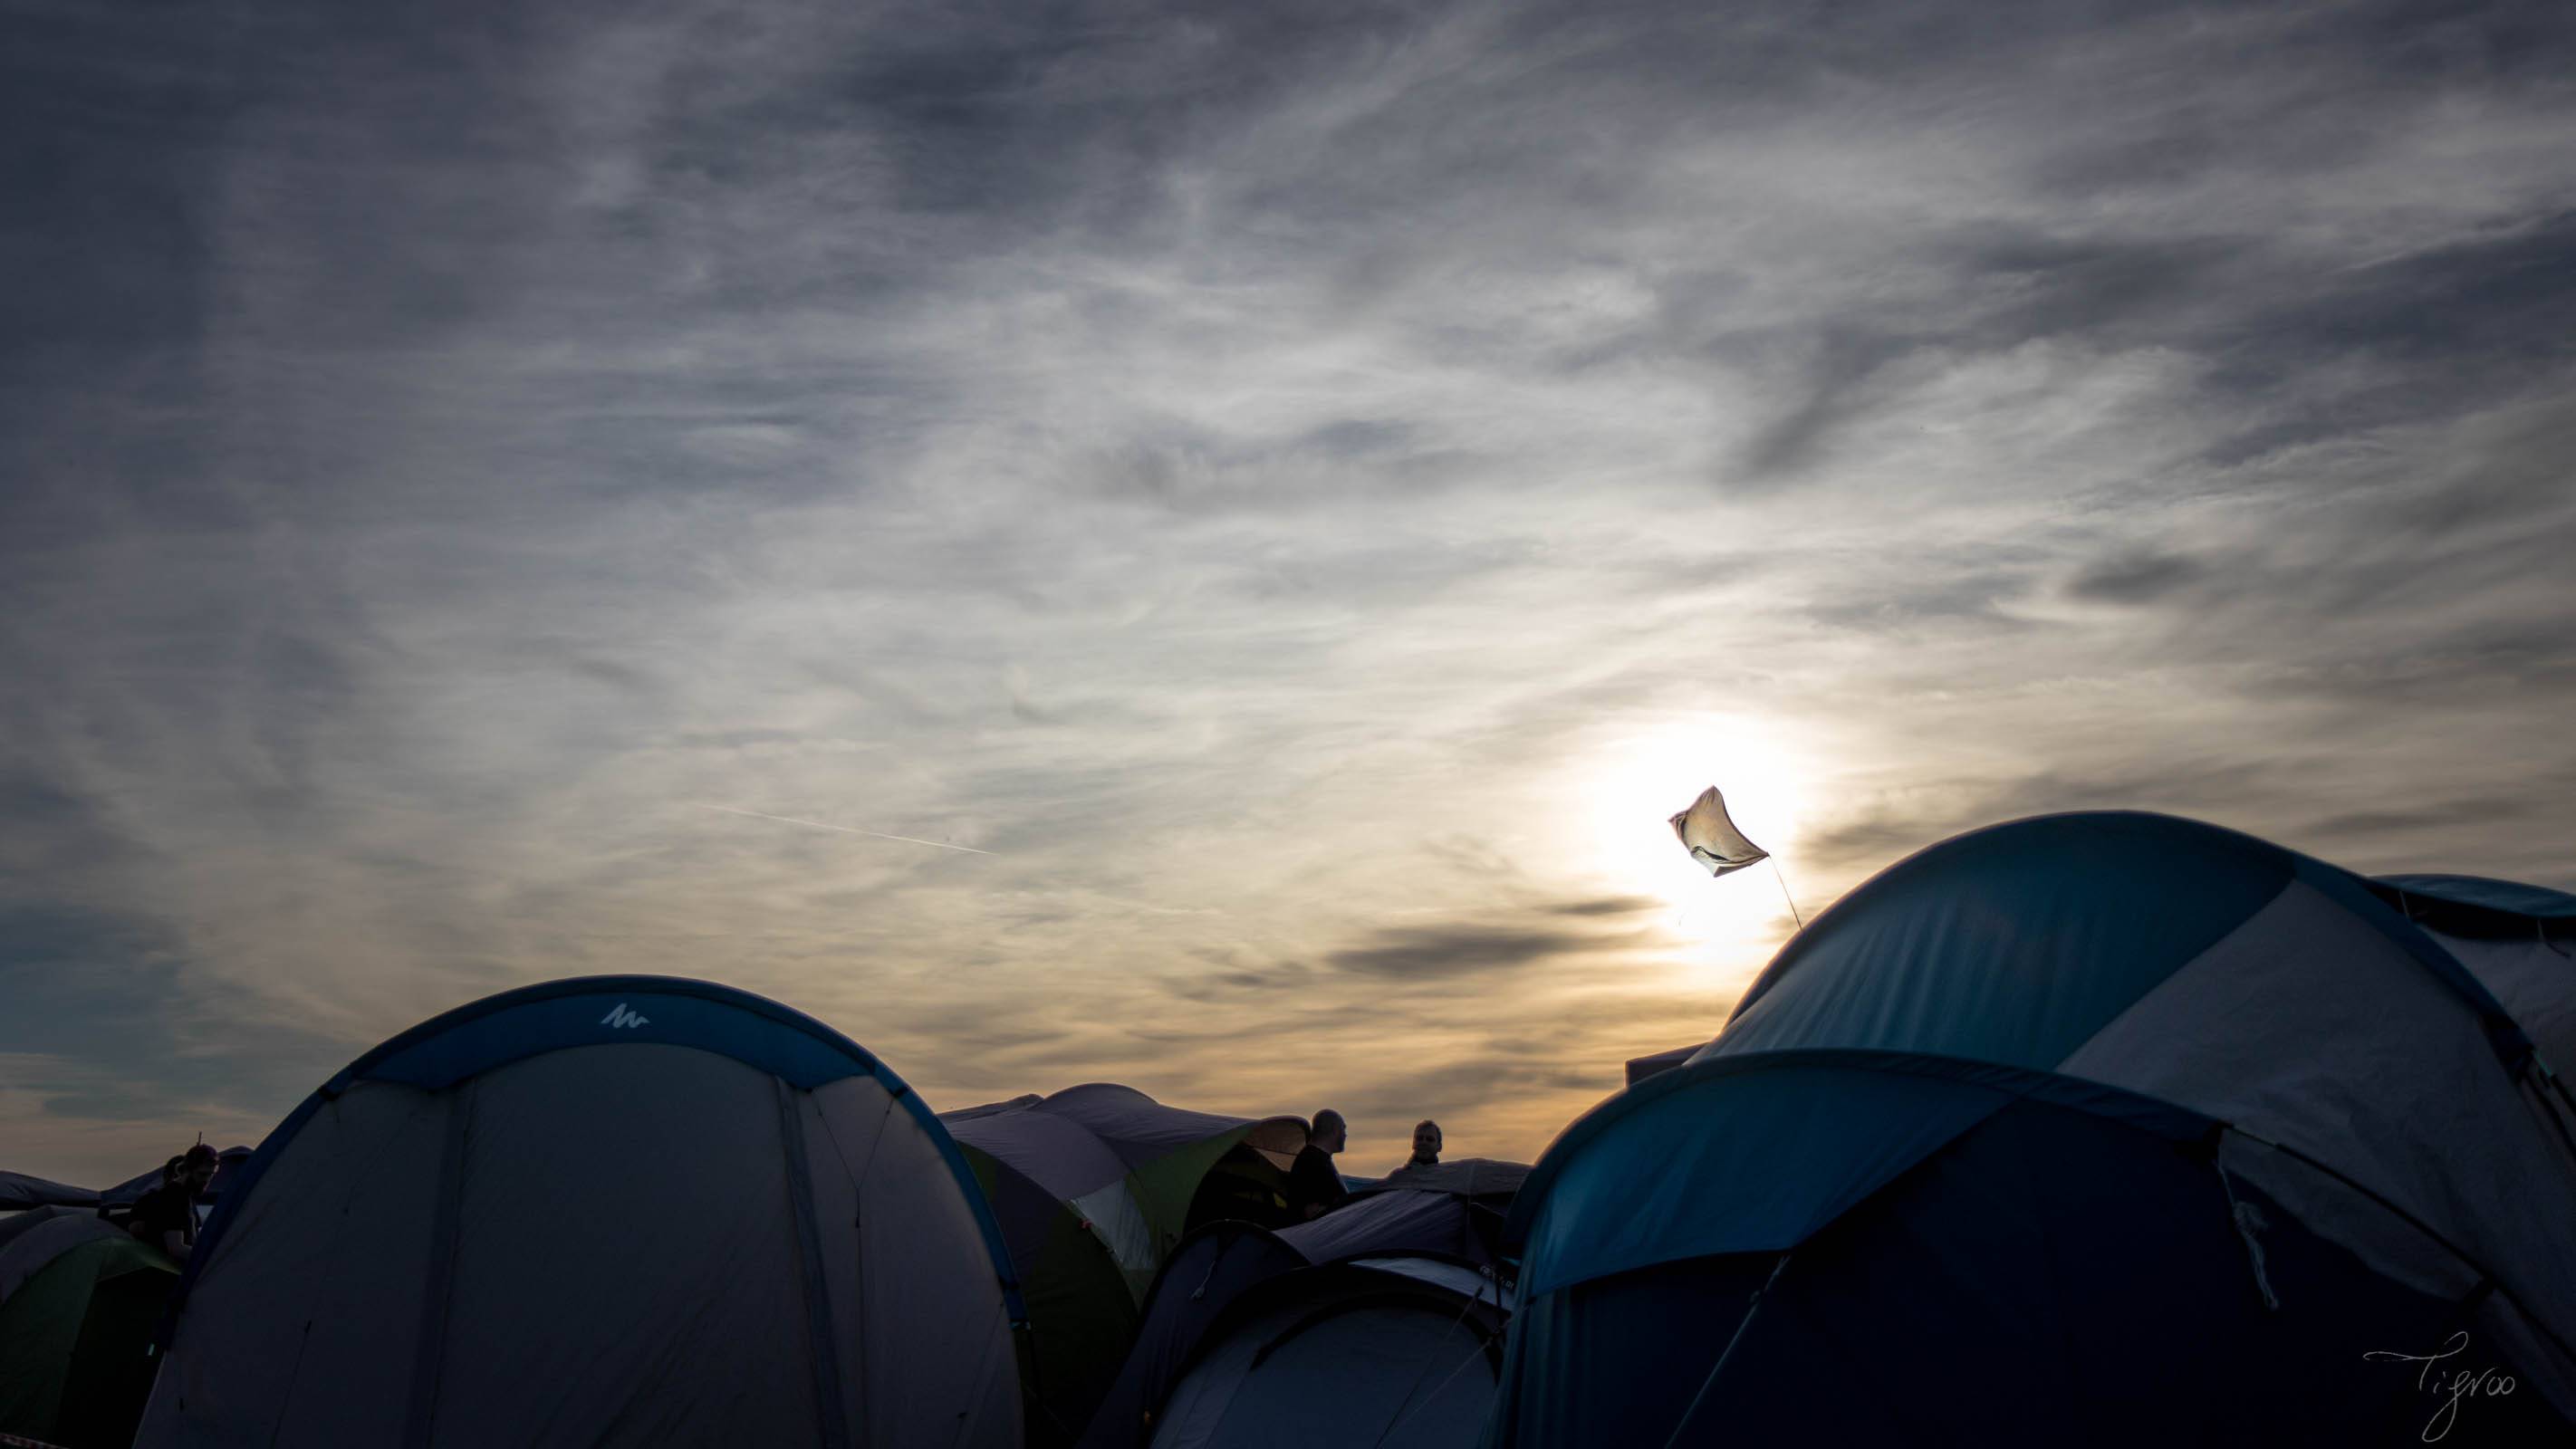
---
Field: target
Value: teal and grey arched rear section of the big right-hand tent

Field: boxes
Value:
[1679,813,2576,1348]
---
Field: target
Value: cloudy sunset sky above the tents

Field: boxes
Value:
[0,0,2576,1184]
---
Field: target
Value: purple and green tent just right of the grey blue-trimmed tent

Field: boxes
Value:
[940,1081,1306,1439]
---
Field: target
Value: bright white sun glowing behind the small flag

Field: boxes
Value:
[1569,715,1813,955]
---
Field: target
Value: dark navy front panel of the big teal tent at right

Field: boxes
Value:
[1489,1101,2568,1449]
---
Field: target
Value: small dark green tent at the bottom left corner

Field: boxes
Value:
[0,1217,178,1449]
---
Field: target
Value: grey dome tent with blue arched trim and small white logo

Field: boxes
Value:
[137,975,1020,1449]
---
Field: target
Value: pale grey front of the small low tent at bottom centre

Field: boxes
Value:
[1149,1263,1502,1449]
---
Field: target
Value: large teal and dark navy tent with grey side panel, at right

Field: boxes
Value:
[1489,813,2576,1449]
